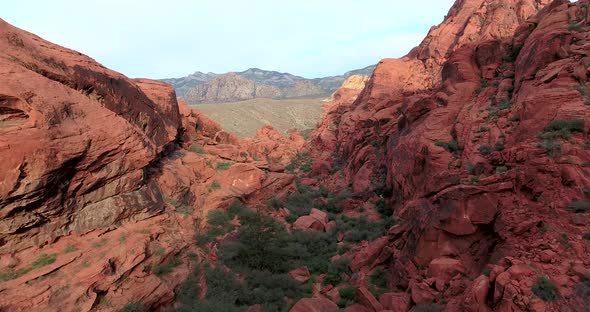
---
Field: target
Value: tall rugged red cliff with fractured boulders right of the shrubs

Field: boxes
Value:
[308,0,590,311]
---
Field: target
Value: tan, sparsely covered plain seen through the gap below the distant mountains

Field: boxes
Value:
[191,98,325,138]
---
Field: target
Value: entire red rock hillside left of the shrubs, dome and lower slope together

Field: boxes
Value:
[0,20,303,311]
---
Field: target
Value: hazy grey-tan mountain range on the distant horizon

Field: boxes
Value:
[162,65,375,104]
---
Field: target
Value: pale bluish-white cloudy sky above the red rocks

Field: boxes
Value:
[0,0,454,78]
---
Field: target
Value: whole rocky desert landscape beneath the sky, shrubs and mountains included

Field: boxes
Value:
[0,0,590,312]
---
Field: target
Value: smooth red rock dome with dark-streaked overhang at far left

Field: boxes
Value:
[0,21,181,252]
